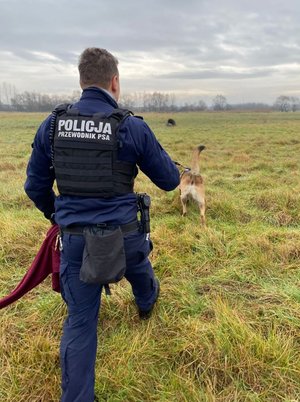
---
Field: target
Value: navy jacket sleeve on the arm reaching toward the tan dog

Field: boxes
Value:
[133,122,180,191]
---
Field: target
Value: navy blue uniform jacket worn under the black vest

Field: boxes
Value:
[24,87,179,227]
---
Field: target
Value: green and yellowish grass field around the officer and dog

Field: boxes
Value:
[0,112,300,402]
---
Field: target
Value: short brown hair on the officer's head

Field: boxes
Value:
[78,47,119,89]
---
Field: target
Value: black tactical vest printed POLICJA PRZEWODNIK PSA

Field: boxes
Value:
[50,105,137,198]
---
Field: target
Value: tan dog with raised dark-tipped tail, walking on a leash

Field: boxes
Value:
[179,145,206,226]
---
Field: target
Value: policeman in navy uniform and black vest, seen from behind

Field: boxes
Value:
[25,48,179,402]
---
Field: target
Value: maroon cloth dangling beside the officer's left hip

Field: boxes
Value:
[0,225,60,309]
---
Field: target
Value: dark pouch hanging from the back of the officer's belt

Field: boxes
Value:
[80,226,126,285]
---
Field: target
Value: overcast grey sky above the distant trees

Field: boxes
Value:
[0,0,300,103]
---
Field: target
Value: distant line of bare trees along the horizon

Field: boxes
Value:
[0,83,300,112]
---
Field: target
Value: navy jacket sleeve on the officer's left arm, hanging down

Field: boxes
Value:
[24,117,55,219]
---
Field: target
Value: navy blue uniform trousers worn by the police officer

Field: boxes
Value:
[60,231,157,402]
